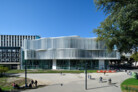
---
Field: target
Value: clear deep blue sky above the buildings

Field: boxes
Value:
[0,0,106,37]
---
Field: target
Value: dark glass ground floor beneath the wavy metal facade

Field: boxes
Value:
[21,60,108,70]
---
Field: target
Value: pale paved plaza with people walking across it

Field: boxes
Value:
[13,72,130,92]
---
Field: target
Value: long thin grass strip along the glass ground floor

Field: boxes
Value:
[6,70,97,73]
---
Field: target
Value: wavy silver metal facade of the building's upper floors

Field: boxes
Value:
[23,36,119,60]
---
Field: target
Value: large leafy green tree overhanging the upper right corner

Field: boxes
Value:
[94,0,138,53]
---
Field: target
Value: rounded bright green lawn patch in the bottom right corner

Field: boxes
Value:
[121,78,138,90]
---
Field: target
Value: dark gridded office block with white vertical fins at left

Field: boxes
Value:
[0,35,40,69]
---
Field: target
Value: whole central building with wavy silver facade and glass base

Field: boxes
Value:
[21,36,120,70]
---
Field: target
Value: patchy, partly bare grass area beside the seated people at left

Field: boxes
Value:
[0,77,31,91]
